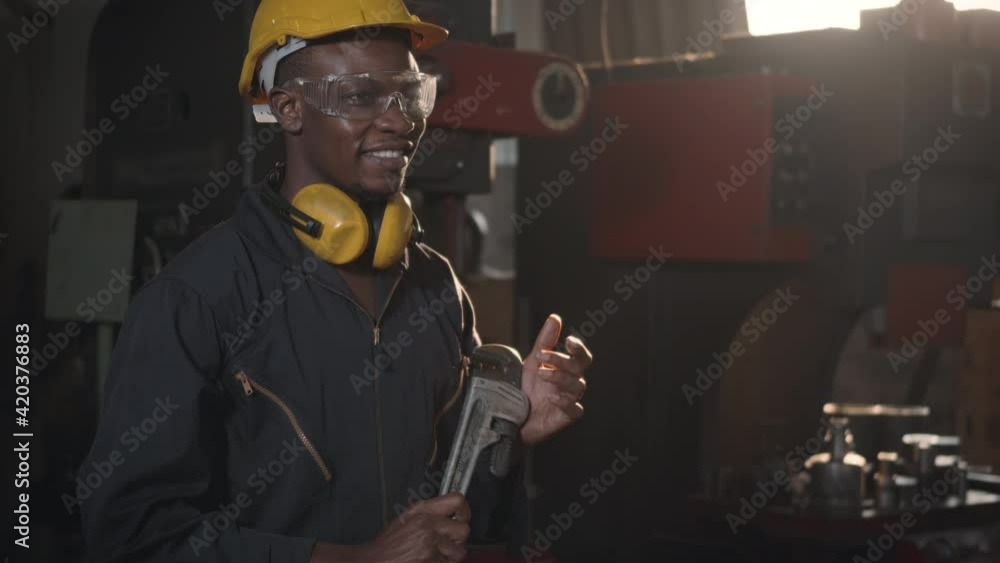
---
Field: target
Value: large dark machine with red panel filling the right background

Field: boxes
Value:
[517,0,1000,561]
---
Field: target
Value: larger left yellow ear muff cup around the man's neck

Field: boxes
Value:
[292,184,370,264]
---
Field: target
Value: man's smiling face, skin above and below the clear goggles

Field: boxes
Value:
[276,29,427,199]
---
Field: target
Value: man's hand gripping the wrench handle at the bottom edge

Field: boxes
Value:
[359,493,471,563]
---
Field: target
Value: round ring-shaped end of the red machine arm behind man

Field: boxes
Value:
[533,62,587,132]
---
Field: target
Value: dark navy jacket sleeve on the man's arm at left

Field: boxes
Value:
[77,279,315,563]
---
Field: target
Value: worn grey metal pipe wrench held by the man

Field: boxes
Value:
[441,344,530,495]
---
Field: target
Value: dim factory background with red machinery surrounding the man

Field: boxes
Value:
[0,0,1000,563]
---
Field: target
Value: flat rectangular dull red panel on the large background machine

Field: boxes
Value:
[591,76,823,262]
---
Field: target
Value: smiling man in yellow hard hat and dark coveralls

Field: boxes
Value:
[79,0,591,563]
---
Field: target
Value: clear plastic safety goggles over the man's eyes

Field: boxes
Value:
[284,70,437,121]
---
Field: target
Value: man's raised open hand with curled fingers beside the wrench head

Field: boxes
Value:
[521,315,594,446]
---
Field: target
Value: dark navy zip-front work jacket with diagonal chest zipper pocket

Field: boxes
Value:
[78,186,504,563]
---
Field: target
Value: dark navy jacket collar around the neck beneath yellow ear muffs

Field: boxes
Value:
[234,183,412,294]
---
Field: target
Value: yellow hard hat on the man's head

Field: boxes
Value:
[240,0,448,104]
